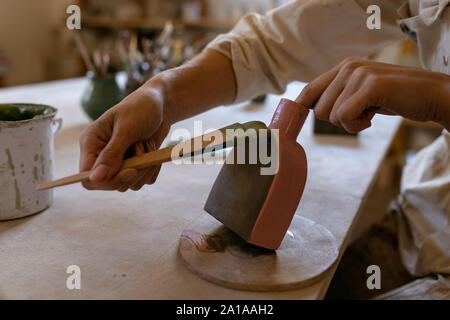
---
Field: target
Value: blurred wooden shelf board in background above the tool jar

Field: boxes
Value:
[81,16,235,29]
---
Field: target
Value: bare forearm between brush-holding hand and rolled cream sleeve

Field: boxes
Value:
[145,50,236,124]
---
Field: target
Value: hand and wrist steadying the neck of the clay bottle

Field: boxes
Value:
[296,58,450,133]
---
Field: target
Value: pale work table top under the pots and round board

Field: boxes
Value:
[0,79,401,299]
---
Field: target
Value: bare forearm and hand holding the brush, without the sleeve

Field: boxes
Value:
[80,50,236,192]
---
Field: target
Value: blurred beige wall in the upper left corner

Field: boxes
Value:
[0,0,76,85]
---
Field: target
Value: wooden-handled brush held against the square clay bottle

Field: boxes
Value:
[37,122,264,190]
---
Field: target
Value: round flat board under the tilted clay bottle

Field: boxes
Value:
[179,214,338,291]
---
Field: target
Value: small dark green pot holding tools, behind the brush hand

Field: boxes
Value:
[81,75,123,120]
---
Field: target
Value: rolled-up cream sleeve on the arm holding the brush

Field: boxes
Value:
[207,0,405,102]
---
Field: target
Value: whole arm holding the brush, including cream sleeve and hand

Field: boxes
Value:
[80,0,404,191]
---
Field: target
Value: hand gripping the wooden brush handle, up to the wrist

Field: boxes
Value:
[80,83,171,192]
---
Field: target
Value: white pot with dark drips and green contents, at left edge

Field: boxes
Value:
[0,103,62,220]
